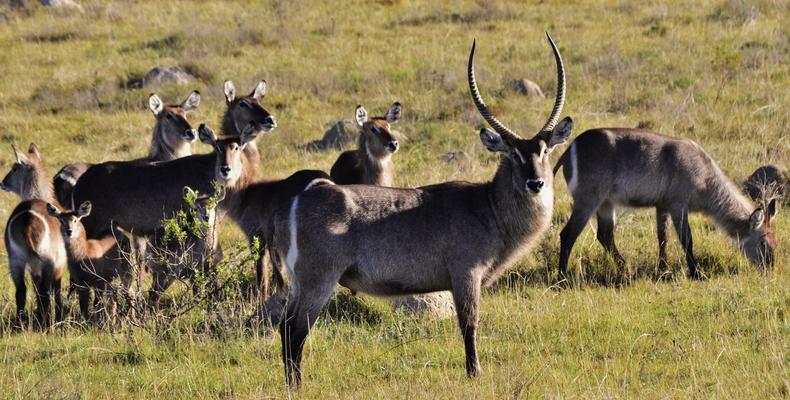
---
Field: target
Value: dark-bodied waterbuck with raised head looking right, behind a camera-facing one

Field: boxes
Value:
[73,81,276,238]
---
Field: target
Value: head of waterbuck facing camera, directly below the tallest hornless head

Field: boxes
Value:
[198,124,258,187]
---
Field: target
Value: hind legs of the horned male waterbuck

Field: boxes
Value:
[280,280,337,387]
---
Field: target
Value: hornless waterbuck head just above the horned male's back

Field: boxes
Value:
[355,102,403,160]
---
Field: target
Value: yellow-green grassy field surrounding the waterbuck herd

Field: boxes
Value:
[0,0,790,399]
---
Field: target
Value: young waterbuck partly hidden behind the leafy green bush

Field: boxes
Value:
[148,186,225,306]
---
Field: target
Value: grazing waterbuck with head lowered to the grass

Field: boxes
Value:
[554,128,776,279]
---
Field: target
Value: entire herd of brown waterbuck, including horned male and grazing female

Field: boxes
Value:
[1,34,777,386]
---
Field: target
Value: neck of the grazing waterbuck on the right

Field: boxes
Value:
[703,168,755,239]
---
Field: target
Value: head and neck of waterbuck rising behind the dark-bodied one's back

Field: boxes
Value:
[148,90,200,161]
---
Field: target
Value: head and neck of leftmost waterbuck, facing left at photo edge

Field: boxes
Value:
[0,143,49,200]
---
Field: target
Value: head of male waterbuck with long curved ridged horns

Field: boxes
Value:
[468,33,573,195]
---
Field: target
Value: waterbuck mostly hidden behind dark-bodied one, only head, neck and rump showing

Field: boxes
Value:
[53,90,200,208]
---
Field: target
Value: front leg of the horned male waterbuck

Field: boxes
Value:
[453,275,482,377]
